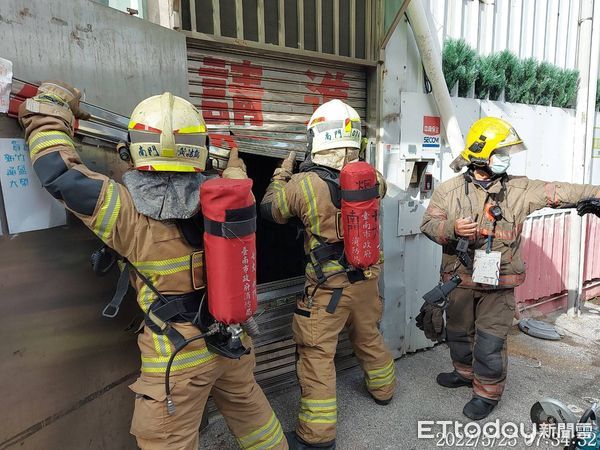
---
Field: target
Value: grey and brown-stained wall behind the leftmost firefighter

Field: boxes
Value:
[0,0,188,450]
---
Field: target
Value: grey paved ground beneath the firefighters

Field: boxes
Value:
[201,303,600,450]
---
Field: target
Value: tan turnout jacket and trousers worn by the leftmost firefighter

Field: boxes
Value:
[19,96,287,450]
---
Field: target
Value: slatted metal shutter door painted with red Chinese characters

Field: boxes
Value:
[188,39,367,392]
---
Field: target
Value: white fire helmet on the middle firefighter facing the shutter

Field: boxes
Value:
[307,99,361,170]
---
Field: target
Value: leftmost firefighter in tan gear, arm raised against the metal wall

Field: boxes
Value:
[19,82,288,450]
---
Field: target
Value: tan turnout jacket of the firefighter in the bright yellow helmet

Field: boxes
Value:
[421,174,599,289]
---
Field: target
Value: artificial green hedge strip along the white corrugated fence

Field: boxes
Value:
[442,39,584,108]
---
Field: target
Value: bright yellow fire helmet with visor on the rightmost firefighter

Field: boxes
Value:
[450,117,526,172]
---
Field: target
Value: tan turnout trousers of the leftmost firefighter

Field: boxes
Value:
[130,325,288,450]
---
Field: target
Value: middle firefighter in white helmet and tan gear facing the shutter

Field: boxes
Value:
[261,100,396,449]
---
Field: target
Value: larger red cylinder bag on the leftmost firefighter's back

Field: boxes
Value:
[200,178,256,325]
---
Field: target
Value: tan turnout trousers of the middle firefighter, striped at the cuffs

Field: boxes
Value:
[292,278,396,444]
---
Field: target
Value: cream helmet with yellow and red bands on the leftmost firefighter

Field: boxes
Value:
[128,92,208,172]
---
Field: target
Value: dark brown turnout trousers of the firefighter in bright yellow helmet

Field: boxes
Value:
[446,288,515,401]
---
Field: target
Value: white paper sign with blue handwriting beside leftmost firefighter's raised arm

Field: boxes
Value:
[0,139,67,234]
